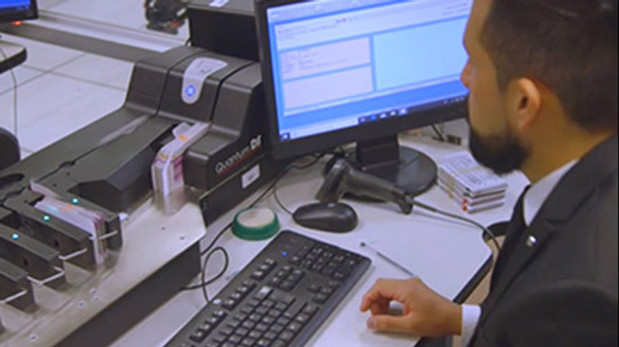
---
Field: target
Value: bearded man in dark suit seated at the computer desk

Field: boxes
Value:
[361,0,618,346]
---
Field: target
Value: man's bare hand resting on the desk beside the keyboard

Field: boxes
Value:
[361,278,462,337]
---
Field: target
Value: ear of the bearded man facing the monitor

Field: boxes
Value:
[512,78,542,130]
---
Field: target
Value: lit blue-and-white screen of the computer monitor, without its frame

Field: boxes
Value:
[267,0,472,142]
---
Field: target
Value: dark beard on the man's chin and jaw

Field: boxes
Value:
[469,127,529,175]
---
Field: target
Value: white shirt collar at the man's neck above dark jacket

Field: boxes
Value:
[523,159,578,227]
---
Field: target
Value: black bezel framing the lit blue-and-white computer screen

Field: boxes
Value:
[255,0,468,158]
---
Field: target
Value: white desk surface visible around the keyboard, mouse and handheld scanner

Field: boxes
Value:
[114,138,527,347]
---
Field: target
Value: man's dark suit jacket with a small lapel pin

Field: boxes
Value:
[470,135,618,347]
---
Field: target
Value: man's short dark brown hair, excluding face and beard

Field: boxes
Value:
[480,0,619,131]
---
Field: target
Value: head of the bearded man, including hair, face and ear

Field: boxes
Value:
[462,0,618,178]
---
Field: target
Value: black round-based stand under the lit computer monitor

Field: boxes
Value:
[332,135,437,200]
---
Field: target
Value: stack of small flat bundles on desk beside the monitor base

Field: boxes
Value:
[438,152,507,213]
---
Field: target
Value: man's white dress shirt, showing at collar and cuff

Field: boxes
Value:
[462,160,578,346]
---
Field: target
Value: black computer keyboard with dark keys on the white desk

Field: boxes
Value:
[166,231,370,347]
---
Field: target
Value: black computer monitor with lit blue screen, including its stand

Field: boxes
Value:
[255,0,472,195]
